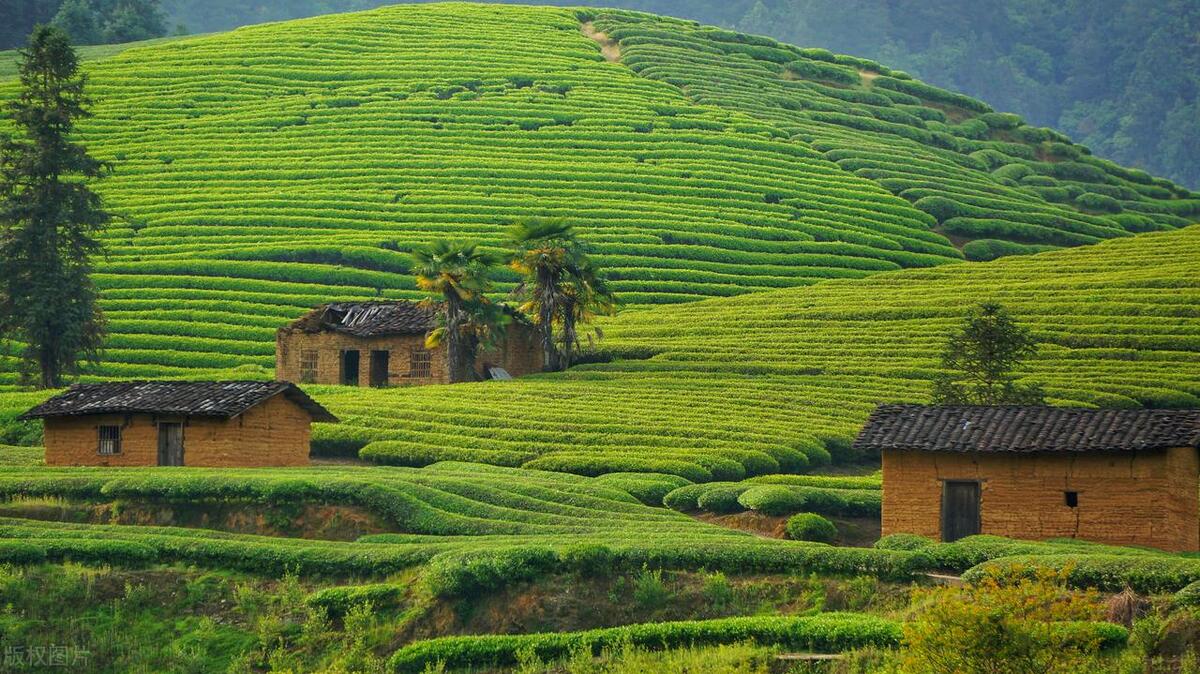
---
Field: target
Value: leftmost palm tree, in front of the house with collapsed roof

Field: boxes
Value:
[413,241,504,381]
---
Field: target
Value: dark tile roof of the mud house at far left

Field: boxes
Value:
[20,381,337,422]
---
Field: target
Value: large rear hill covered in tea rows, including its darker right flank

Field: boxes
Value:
[0,4,1200,385]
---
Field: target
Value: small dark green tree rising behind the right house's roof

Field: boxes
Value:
[934,302,1045,405]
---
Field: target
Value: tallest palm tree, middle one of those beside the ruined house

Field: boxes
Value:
[509,219,581,371]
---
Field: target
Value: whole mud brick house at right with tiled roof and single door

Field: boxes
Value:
[854,405,1200,552]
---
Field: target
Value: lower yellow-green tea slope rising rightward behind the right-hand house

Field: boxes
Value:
[314,227,1200,481]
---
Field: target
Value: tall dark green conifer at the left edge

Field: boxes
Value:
[0,26,109,387]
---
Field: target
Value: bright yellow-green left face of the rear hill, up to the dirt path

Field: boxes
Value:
[0,4,961,381]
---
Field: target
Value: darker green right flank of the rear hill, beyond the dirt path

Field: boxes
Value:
[595,12,1200,259]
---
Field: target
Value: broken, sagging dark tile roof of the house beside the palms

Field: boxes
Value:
[287,300,437,337]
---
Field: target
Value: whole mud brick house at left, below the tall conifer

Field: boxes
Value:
[22,381,337,467]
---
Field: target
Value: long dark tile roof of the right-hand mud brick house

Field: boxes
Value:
[854,405,1200,452]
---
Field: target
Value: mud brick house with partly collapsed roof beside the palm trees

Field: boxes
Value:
[275,301,545,386]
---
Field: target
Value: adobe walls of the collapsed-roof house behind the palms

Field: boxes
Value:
[275,325,542,386]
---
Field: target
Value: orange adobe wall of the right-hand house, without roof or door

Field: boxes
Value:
[883,447,1200,550]
